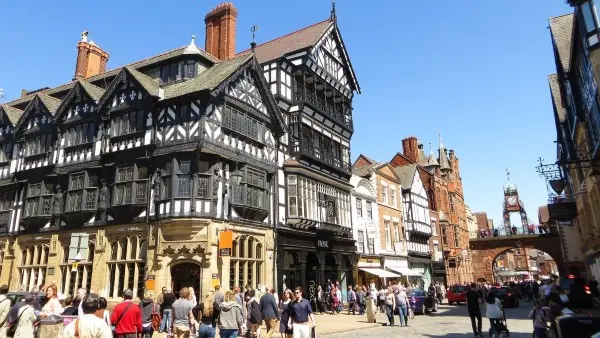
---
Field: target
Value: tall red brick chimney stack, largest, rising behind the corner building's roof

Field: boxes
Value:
[204,2,237,60]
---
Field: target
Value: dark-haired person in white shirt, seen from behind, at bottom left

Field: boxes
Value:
[63,293,112,338]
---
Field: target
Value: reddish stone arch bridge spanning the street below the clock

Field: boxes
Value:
[469,235,568,282]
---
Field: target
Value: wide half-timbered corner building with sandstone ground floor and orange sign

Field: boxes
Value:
[0,4,296,300]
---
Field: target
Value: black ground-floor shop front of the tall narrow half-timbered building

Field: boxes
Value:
[277,228,356,302]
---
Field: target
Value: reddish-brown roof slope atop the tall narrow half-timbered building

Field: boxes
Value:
[238,19,333,63]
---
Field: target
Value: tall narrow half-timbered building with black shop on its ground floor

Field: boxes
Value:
[248,12,360,297]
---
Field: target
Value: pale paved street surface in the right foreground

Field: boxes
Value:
[318,302,533,338]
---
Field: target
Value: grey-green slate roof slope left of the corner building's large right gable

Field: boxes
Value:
[165,54,252,99]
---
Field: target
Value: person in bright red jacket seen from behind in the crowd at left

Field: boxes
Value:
[111,289,142,338]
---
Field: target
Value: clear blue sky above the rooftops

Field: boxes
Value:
[0,0,571,224]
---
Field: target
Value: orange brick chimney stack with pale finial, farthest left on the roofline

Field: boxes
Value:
[73,32,108,80]
